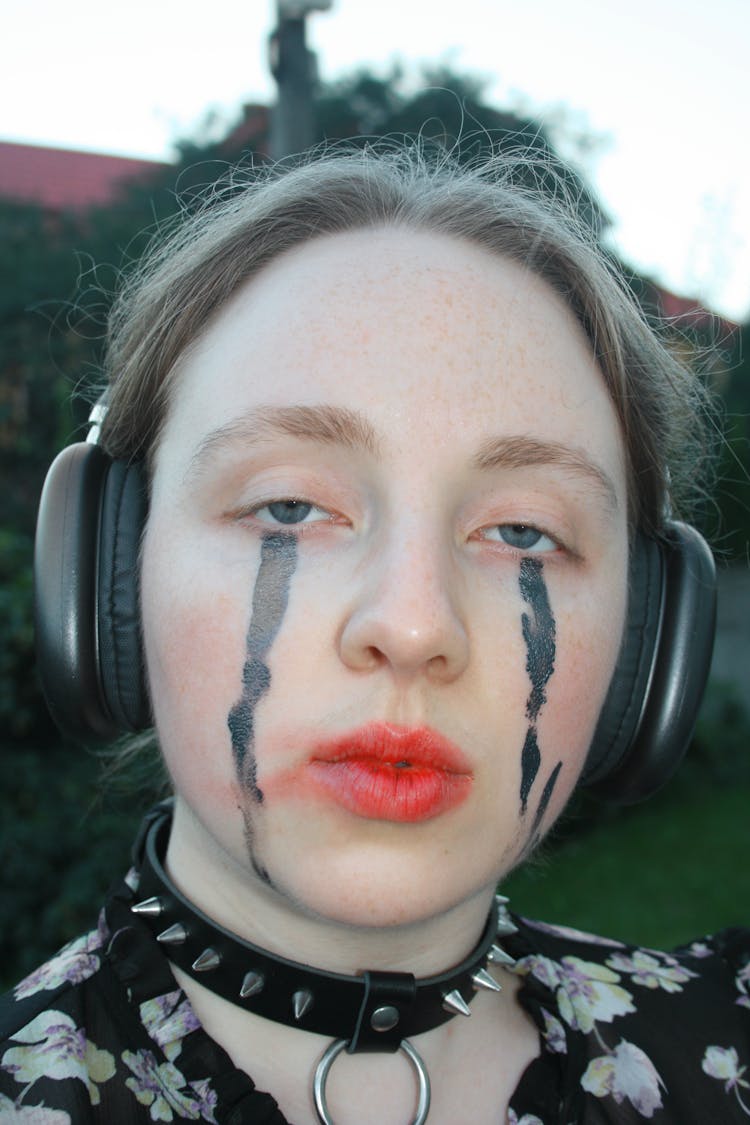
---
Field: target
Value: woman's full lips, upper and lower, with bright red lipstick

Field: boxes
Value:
[308,724,471,824]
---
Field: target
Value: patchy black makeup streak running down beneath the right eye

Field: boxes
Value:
[518,558,557,820]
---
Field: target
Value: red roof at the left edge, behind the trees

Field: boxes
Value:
[0,142,164,212]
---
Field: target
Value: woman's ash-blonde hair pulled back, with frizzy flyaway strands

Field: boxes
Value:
[100,144,705,534]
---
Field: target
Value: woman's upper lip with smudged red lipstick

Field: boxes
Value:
[311,722,472,775]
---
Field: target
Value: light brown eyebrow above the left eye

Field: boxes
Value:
[188,404,379,474]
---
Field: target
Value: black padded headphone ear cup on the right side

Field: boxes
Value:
[580,523,716,804]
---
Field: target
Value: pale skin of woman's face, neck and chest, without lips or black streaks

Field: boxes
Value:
[137,223,627,1125]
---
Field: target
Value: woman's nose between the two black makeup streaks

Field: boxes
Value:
[340,533,469,682]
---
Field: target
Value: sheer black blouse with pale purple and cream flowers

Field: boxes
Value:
[0,850,750,1125]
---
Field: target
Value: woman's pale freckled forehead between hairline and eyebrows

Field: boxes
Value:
[165,228,622,490]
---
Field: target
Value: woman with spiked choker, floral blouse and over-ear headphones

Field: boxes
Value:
[0,145,750,1125]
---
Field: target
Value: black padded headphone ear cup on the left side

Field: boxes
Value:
[34,443,151,740]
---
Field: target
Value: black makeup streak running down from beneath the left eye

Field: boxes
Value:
[227,532,297,803]
